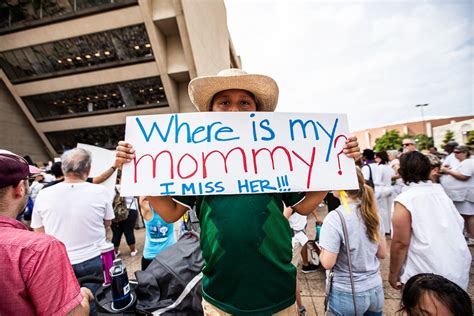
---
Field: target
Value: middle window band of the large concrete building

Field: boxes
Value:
[23,77,168,122]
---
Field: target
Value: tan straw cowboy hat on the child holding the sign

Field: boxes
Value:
[188,69,278,112]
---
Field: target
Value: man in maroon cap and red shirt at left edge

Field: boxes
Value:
[0,150,93,315]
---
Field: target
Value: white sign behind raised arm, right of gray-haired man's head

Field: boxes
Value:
[77,143,117,200]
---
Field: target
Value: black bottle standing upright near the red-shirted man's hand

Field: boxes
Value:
[110,259,132,311]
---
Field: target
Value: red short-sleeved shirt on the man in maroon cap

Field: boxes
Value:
[0,216,83,315]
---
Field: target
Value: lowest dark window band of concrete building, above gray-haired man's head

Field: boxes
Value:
[45,125,125,154]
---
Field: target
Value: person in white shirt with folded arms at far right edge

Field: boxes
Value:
[441,146,474,246]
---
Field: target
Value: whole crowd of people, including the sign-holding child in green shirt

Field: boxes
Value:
[0,69,474,315]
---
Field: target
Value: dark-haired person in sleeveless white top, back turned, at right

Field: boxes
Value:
[389,151,472,289]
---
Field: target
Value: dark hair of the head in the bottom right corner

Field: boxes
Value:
[398,273,472,316]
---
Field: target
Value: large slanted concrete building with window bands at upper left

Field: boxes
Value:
[0,0,241,161]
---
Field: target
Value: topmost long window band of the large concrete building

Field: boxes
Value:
[0,24,153,83]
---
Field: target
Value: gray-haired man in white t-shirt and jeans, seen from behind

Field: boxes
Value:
[31,148,114,292]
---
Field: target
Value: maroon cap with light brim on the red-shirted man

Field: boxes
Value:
[0,150,41,188]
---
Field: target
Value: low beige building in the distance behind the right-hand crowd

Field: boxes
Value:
[353,115,474,149]
